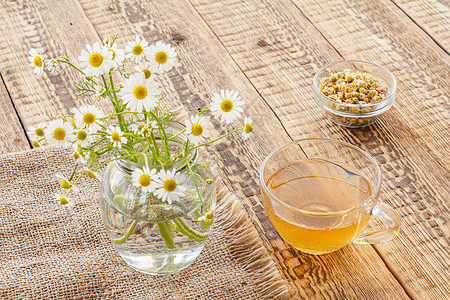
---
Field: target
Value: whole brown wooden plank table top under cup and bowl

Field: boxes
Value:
[0,0,450,299]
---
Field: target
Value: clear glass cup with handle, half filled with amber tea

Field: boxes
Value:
[260,139,400,254]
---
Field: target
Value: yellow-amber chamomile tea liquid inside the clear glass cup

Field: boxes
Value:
[262,159,372,254]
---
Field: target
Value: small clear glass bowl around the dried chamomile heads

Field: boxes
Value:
[313,60,397,128]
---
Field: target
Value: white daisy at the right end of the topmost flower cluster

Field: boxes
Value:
[145,41,177,74]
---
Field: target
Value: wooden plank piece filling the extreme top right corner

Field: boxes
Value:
[392,0,450,53]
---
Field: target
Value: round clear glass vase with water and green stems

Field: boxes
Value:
[100,133,216,275]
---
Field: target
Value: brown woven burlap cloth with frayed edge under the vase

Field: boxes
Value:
[0,148,292,299]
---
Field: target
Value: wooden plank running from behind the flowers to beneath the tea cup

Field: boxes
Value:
[80,0,408,299]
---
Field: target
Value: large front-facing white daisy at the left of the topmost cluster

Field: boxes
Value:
[78,42,113,77]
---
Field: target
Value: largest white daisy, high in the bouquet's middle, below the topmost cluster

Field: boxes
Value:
[119,73,159,112]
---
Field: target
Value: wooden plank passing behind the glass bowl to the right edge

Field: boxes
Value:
[293,0,450,171]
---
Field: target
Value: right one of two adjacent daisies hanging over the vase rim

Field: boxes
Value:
[155,169,186,204]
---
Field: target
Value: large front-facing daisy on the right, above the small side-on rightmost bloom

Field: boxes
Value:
[211,90,244,124]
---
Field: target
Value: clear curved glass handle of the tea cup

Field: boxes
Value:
[353,203,400,244]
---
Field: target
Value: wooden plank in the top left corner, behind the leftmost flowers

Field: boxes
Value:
[0,1,109,132]
